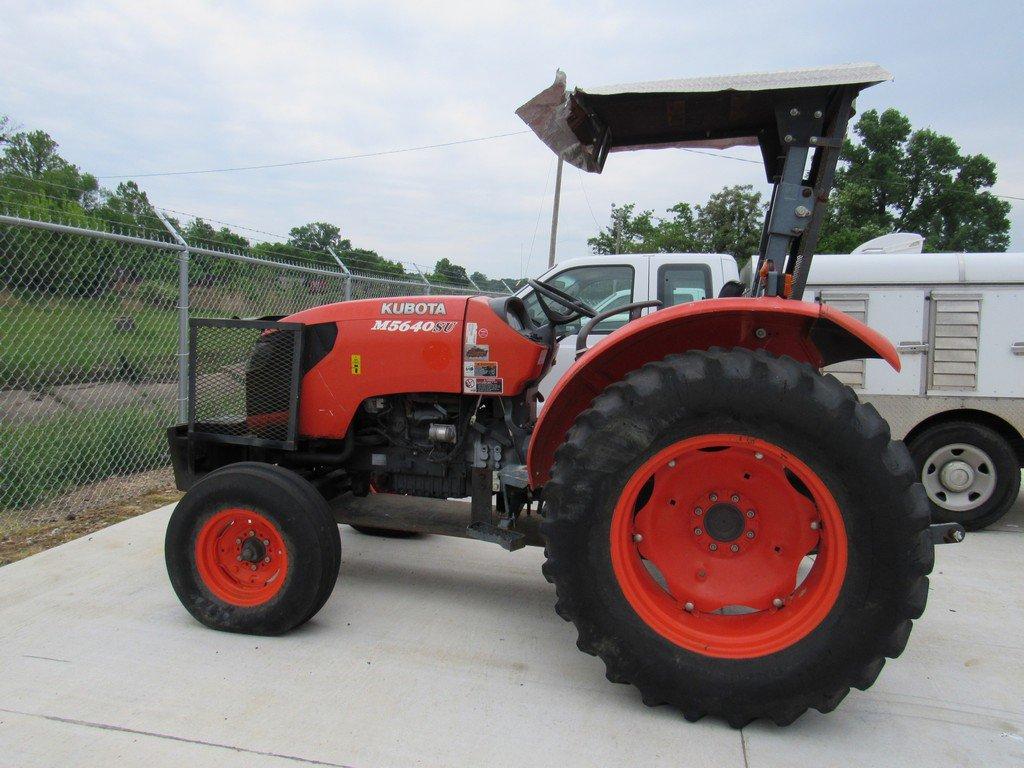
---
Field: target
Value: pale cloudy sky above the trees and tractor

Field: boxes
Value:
[0,0,1024,276]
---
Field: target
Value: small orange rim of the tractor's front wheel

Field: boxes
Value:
[196,508,288,607]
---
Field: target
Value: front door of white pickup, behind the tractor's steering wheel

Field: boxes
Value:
[522,256,647,408]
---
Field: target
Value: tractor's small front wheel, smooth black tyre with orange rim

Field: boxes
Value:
[164,462,341,635]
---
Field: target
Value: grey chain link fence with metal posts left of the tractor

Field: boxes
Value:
[0,211,499,535]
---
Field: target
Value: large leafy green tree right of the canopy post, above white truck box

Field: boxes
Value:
[818,109,1010,253]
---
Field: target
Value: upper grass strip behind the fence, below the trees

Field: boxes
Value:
[0,296,178,389]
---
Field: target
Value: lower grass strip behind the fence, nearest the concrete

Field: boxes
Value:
[0,404,173,511]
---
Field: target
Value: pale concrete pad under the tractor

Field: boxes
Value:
[0,493,1024,768]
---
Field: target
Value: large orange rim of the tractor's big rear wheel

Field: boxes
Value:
[611,434,847,658]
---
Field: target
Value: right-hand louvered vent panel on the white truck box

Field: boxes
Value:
[928,293,981,389]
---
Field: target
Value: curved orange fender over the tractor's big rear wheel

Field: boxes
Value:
[526,298,900,487]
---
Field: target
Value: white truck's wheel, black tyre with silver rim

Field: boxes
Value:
[908,422,1021,530]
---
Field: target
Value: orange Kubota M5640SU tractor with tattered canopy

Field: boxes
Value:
[165,65,964,727]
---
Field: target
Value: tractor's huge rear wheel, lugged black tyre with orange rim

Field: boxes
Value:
[542,349,934,727]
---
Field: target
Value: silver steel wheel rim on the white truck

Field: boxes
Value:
[921,442,996,512]
